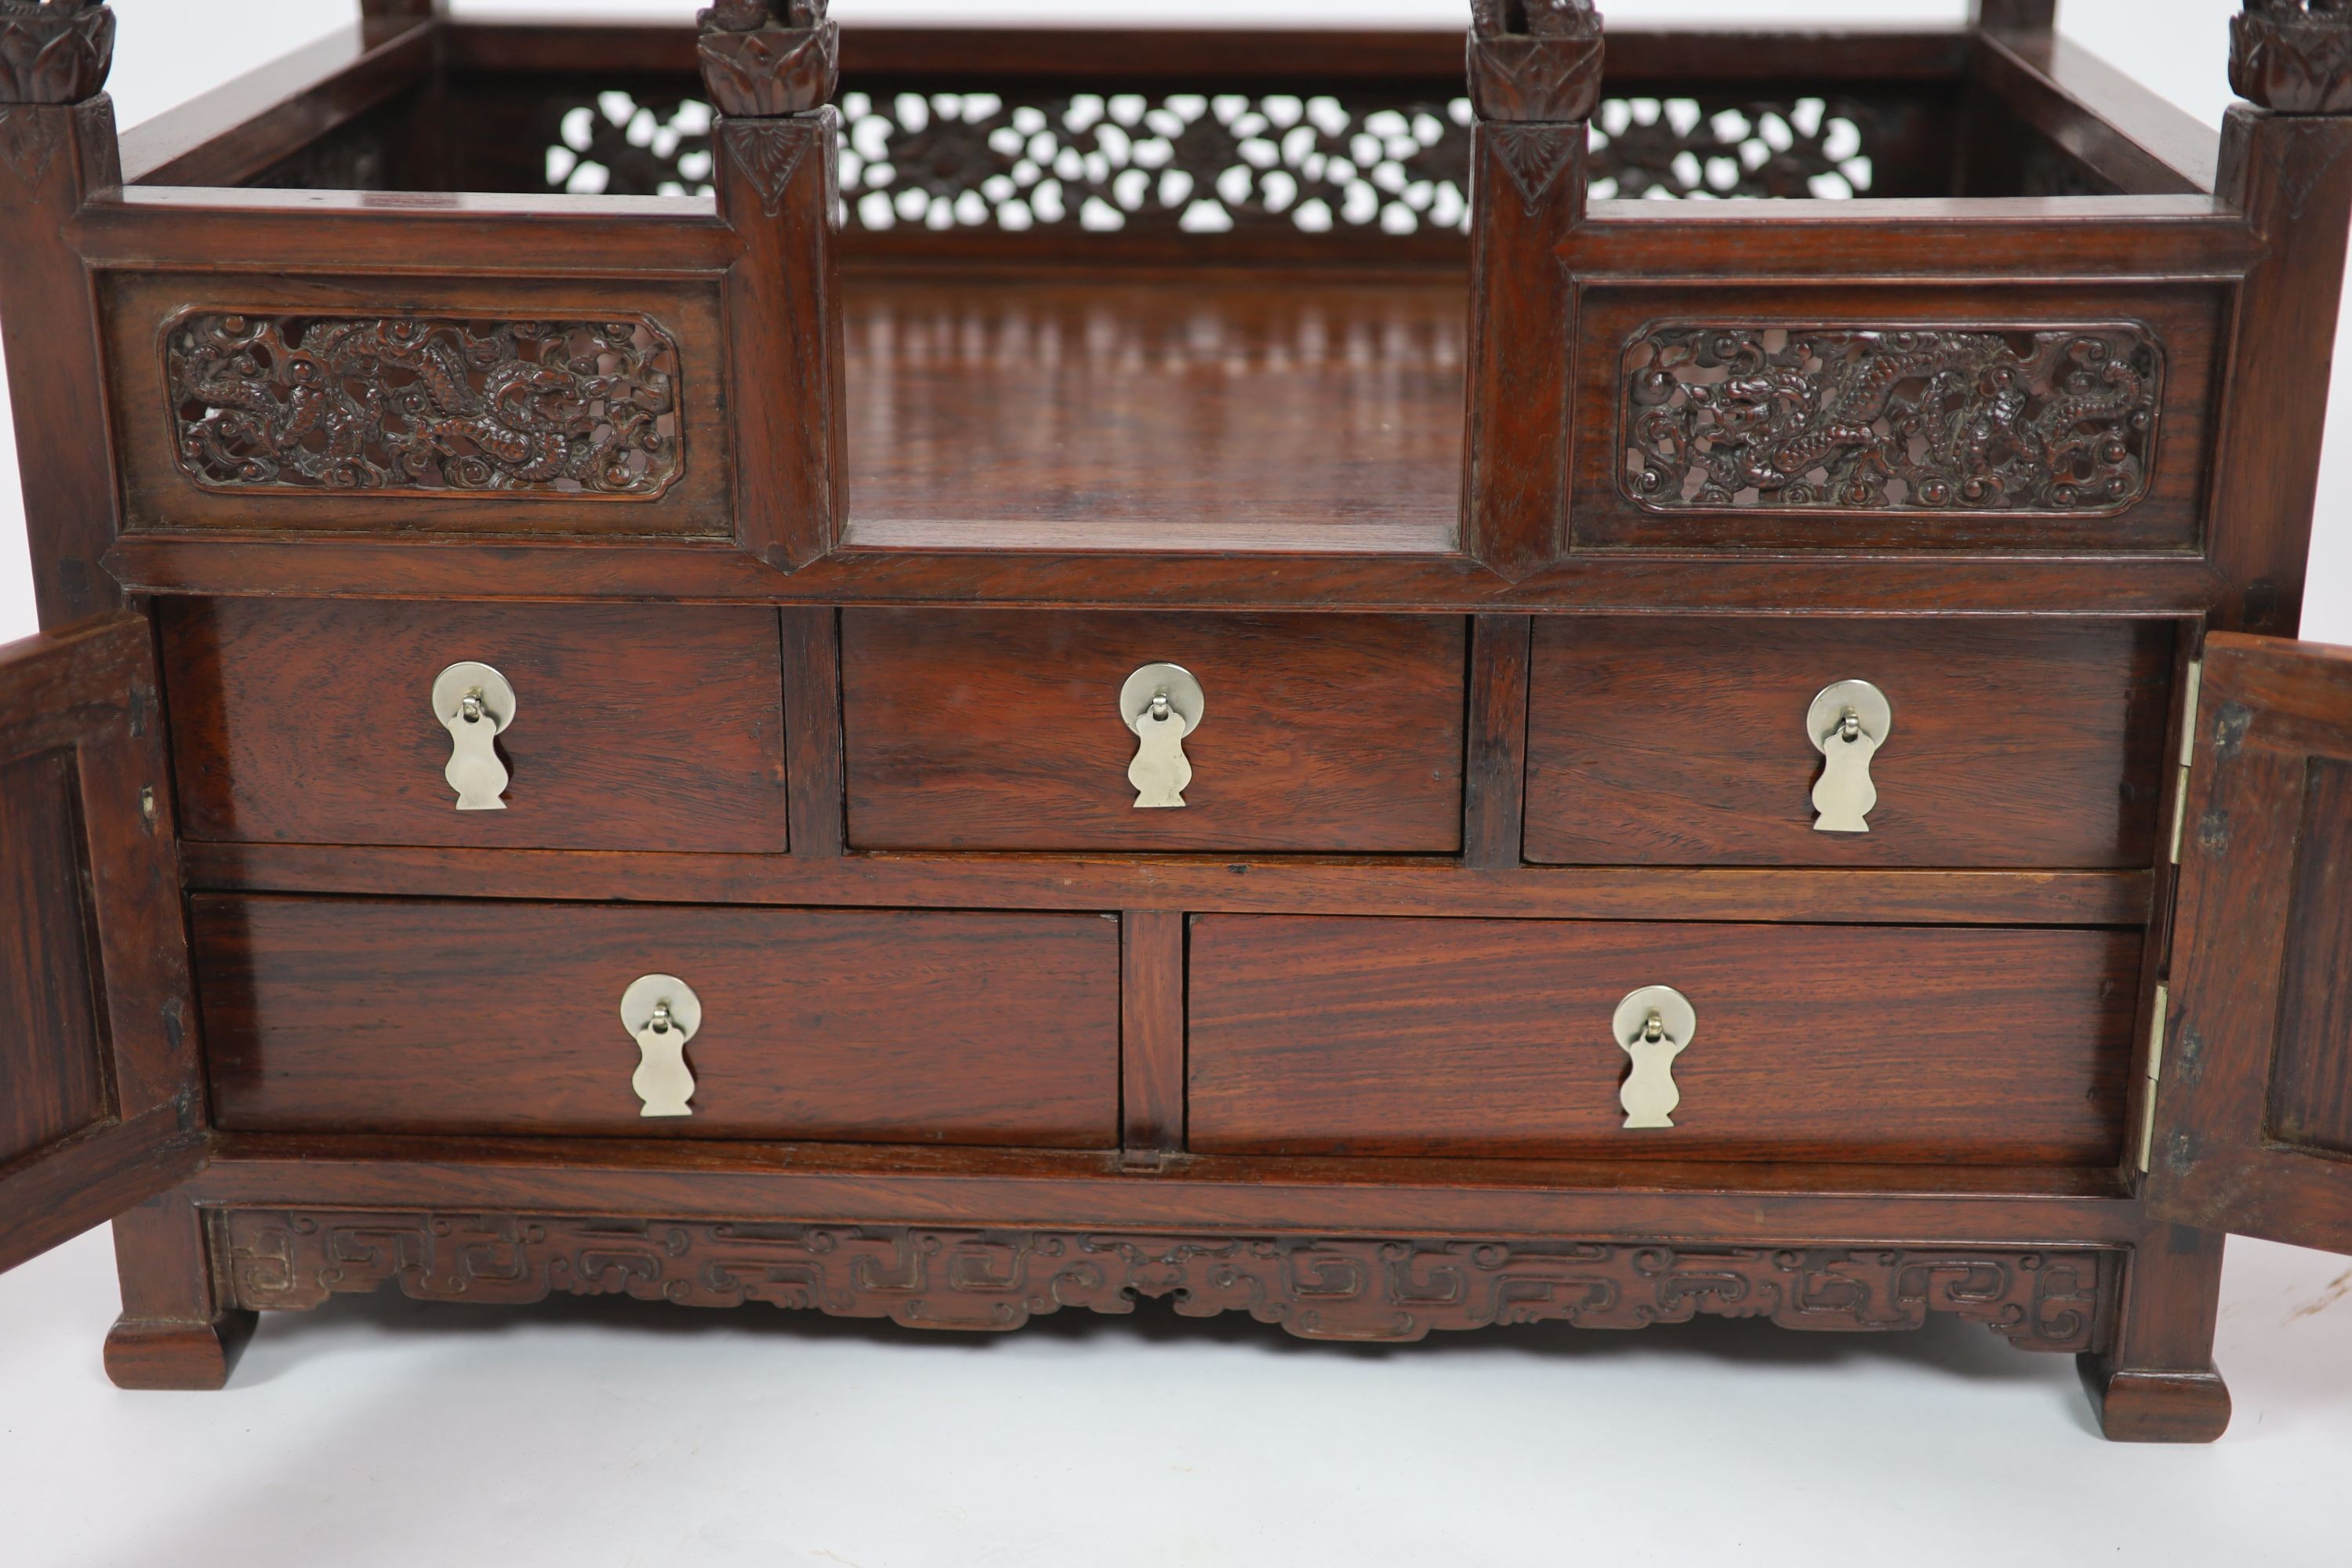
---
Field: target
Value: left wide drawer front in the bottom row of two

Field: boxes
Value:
[193,895,1120,1147]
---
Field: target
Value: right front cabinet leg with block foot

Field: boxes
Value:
[2077,1225,2230,1443]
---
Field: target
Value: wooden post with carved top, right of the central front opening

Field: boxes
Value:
[1463,0,1602,583]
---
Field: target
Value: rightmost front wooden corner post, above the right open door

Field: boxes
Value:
[2211,0,2352,637]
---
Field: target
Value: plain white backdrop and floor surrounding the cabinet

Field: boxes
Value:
[0,0,2352,1568]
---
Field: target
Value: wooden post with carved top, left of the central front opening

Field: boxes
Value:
[701,0,849,572]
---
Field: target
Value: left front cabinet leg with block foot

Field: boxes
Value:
[106,1192,256,1389]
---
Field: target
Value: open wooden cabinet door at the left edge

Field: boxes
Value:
[0,616,207,1269]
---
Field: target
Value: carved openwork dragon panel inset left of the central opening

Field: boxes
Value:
[162,310,684,501]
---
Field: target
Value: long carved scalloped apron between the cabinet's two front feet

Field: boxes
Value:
[219,1210,2117,1352]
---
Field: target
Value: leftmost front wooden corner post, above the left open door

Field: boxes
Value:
[0,0,122,630]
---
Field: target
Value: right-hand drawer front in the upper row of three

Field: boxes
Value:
[1526,619,2173,869]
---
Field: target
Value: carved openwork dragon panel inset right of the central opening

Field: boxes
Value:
[1621,322,2164,513]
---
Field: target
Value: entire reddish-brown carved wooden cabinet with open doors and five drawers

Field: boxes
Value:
[0,0,2352,1439]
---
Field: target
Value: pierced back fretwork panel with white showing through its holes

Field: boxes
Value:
[546,92,1875,235]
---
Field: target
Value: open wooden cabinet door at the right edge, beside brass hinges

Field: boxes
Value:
[2147,635,2352,1253]
